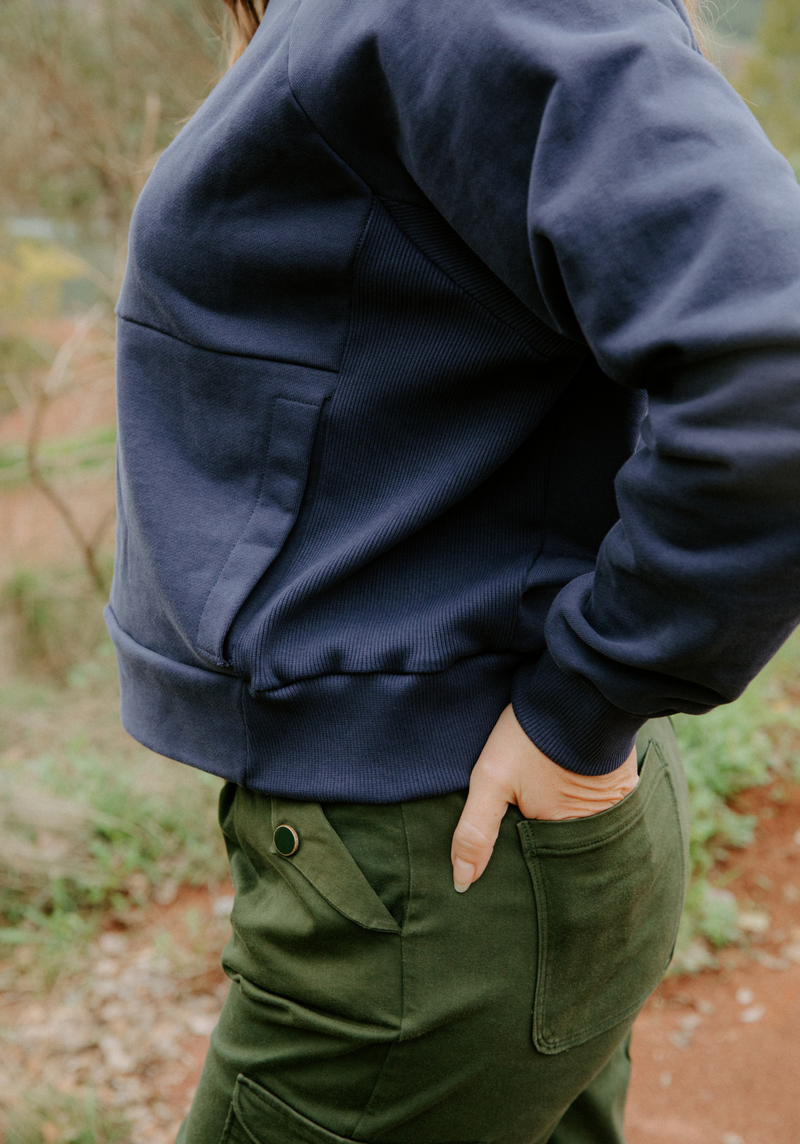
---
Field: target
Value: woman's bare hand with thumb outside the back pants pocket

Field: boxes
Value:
[451,705,639,893]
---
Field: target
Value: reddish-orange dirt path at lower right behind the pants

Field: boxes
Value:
[627,784,800,1144]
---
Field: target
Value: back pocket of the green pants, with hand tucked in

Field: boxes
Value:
[518,721,688,1054]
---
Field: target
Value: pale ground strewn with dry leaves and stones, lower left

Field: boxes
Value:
[0,887,232,1144]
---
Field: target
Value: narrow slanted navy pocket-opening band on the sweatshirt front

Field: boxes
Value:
[197,397,320,667]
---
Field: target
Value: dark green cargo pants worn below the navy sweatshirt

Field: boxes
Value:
[177,720,688,1144]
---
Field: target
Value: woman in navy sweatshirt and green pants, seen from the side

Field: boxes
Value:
[109,0,800,1144]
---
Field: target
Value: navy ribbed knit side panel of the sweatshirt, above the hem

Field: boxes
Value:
[230,204,578,696]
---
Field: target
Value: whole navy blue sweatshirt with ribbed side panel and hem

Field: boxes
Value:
[108,0,800,802]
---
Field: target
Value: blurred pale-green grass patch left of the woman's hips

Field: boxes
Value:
[0,639,227,979]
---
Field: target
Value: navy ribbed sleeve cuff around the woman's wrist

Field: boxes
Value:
[512,651,647,774]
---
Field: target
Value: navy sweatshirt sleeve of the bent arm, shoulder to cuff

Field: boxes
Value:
[387,0,800,773]
